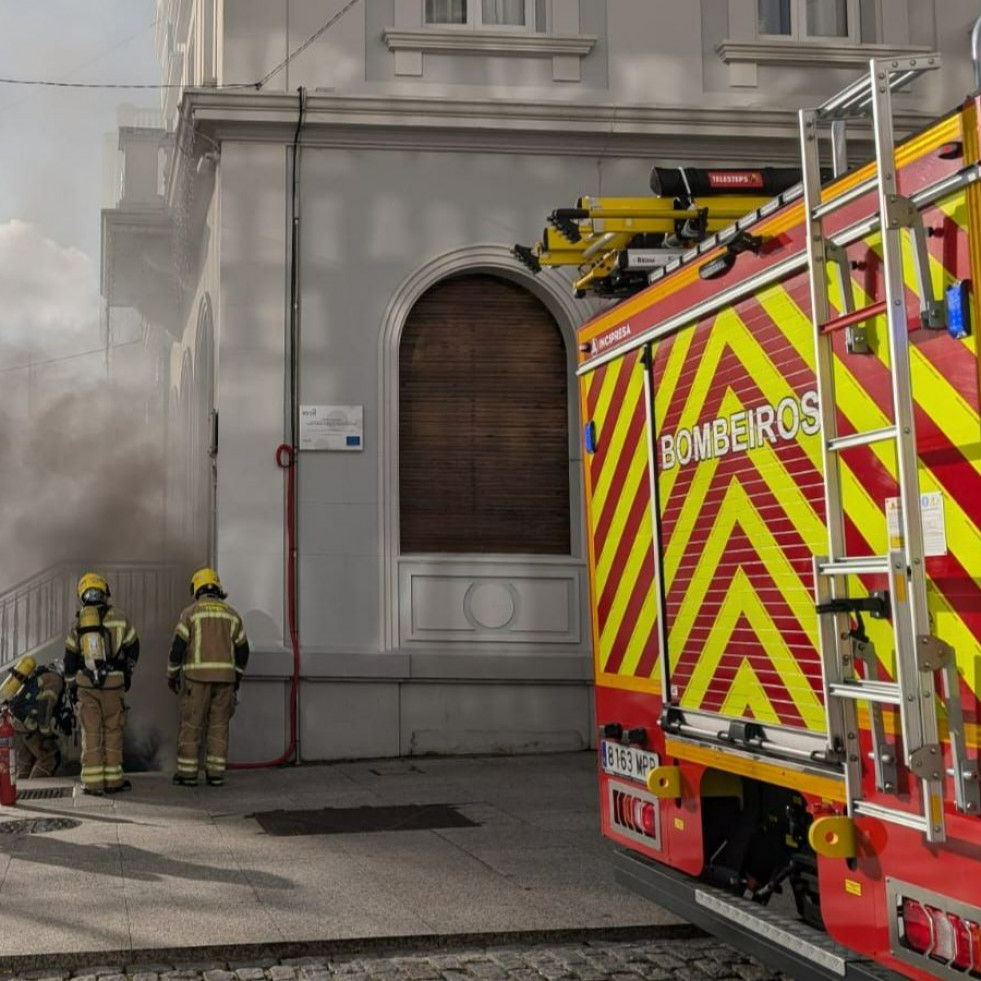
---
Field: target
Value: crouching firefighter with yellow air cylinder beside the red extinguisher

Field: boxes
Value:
[0,656,74,780]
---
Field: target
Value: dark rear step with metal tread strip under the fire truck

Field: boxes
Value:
[613,850,899,981]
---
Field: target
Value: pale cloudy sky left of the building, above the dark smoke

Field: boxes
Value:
[0,0,160,364]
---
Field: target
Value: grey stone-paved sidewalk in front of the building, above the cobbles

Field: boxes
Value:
[0,753,680,971]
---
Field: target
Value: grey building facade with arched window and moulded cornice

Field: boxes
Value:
[103,0,978,760]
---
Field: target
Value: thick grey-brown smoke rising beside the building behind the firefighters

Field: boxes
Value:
[0,221,205,768]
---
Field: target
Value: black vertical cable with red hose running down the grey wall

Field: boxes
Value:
[228,88,306,770]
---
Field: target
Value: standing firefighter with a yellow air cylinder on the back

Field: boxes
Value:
[65,572,140,796]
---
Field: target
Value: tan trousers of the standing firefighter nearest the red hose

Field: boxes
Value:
[177,678,235,783]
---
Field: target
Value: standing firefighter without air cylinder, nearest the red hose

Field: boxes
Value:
[167,568,249,787]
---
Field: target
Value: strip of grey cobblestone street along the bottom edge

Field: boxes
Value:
[2,939,784,981]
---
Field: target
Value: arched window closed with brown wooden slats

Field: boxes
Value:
[399,275,570,555]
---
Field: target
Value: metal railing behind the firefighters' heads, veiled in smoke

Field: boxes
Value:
[0,562,187,668]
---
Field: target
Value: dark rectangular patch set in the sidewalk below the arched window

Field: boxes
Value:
[252,804,479,837]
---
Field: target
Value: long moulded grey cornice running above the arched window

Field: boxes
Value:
[167,88,932,208]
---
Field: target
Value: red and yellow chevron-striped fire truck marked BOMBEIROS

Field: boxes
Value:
[578,56,981,979]
